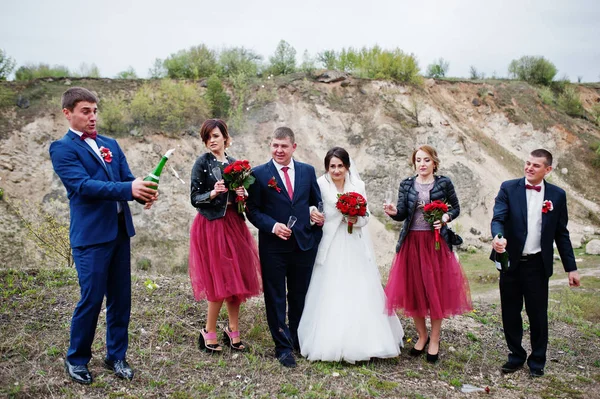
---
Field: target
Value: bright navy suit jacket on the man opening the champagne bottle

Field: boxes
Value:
[50,130,135,248]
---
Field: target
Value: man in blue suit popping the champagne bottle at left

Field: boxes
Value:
[50,87,157,384]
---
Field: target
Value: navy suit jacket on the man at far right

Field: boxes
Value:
[490,178,577,277]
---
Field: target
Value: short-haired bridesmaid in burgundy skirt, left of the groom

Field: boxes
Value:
[189,119,262,353]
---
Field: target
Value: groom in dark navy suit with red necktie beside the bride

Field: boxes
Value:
[247,127,324,367]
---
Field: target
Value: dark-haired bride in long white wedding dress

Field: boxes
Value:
[298,147,404,363]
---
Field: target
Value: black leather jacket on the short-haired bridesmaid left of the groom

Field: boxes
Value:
[190,152,244,220]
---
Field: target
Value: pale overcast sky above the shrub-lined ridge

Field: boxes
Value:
[0,0,600,82]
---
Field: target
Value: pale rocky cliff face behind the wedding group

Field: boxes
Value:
[0,76,600,272]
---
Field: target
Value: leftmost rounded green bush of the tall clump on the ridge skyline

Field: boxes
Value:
[163,44,217,79]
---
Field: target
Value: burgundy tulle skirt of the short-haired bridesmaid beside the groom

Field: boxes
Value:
[189,206,262,304]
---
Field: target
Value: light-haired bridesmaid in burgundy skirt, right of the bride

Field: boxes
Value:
[384,145,472,363]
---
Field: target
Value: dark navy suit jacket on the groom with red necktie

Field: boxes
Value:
[246,160,323,252]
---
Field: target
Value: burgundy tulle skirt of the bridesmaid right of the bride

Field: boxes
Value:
[385,231,473,320]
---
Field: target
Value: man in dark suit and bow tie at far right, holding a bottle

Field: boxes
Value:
[490,149,579,377]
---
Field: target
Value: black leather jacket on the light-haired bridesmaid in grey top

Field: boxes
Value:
[392,176,460,252]
